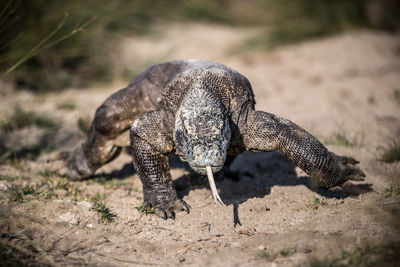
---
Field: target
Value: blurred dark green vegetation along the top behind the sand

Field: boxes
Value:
[0,0,399,92]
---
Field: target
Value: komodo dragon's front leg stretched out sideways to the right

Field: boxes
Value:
[244,110,365,188]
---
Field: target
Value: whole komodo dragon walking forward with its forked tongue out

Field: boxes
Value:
[59,60,365,219]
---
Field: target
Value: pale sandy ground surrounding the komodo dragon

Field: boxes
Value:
[0,24,400,266]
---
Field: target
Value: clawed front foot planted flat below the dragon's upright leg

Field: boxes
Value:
[143,192,191,220]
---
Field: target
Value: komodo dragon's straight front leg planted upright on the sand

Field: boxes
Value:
[130,111,190,219]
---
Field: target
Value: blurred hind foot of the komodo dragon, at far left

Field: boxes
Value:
[49,146,94,180]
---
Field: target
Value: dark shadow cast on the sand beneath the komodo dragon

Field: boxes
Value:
[174,152,372,226]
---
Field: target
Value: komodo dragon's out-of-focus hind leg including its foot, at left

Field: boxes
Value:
[57,85,155,180]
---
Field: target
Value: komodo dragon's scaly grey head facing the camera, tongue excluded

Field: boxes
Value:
[174,88,231,175]
